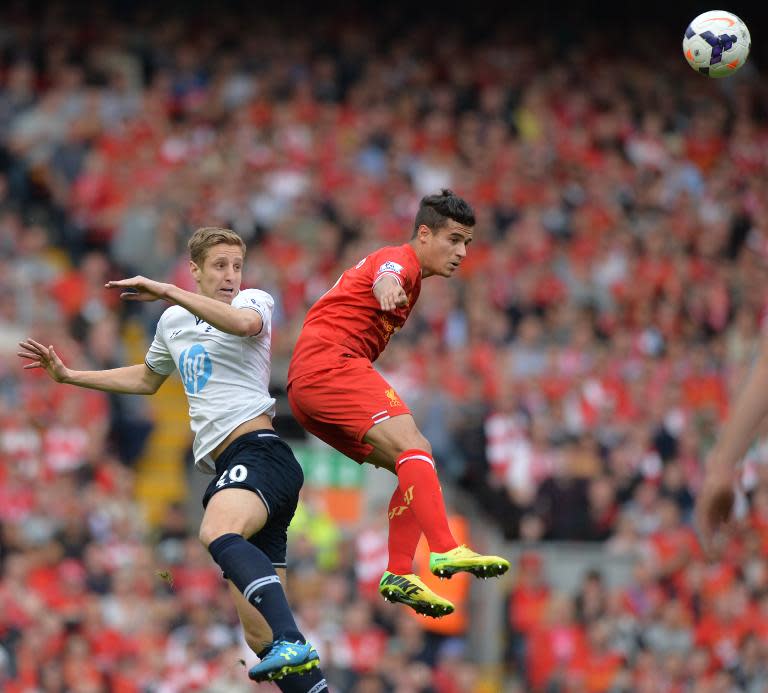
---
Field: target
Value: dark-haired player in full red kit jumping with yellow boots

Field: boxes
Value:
[288,190,509,617]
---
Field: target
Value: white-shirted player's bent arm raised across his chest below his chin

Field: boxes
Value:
[106,276,262,337]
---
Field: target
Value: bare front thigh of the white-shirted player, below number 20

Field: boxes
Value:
[200,488,269,546]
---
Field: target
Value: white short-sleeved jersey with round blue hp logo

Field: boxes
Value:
[145,289,275,474]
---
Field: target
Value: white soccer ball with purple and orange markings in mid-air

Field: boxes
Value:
[683,10,752,77]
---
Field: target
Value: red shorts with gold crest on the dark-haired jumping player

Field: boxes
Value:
[288,357,411,462]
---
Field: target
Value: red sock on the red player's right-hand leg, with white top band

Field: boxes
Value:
[395,450,458,553]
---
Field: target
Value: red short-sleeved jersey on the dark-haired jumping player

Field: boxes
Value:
[288,243,421,383]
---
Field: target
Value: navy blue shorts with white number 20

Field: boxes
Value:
[203,429,304,568]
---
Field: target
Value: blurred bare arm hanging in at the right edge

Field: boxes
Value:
[696,340,768,552]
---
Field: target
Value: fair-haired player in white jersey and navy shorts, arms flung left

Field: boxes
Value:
[19,227,327,693]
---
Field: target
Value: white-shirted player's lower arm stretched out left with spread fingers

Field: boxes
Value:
[18,339,168,395]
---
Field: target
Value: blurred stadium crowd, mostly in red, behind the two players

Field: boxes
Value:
[0,3,768,693]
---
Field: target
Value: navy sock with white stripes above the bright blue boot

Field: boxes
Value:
[208,534,304,643]
